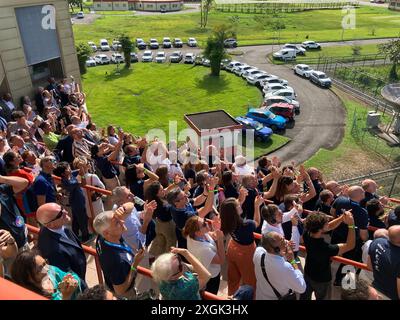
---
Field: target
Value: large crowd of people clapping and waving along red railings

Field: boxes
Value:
[0,78,400,300]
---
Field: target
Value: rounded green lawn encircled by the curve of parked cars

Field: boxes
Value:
[83,63,290,157]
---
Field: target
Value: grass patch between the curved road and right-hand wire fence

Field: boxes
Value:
[305,90,400,180]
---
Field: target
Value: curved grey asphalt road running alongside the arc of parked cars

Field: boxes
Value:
[91,39,388,163]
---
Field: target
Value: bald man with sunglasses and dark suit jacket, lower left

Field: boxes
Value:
[36,202,86,287]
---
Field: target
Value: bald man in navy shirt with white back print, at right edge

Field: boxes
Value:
[367,226,400,300]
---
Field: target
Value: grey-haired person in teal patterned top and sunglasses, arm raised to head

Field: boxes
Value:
[151,247,211,300]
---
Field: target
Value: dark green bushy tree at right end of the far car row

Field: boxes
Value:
[203,25,236,77]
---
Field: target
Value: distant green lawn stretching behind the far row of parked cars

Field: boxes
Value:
[73,7,400,45]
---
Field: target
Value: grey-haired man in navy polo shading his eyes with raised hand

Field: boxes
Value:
[93,203,144,299]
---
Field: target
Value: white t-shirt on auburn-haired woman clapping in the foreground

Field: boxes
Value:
[187,234,221,278]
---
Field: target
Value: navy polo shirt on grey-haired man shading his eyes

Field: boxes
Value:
[96,236,135,291]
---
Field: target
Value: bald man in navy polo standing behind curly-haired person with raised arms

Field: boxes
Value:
[331,186,369,286]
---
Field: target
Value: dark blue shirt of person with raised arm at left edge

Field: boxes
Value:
[0,184,27,248]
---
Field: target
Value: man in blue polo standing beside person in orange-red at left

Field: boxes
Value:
[32,156,57,207]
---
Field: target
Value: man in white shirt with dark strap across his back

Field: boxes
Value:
[253,232,306,300]
